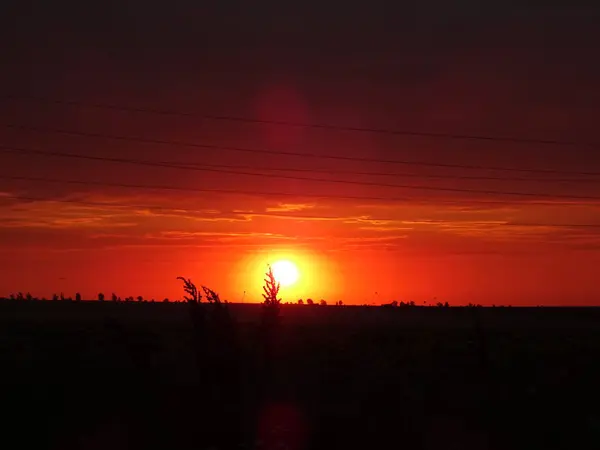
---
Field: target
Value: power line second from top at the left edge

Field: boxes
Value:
[0,124,600,176]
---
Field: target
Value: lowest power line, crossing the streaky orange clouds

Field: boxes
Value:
[0,192,600,228]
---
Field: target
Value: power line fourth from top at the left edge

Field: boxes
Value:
[0,175,596,205]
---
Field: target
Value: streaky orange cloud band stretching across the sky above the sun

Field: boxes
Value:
[0,188,600,255]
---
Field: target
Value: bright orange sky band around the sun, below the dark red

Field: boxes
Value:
[0,188,600,304]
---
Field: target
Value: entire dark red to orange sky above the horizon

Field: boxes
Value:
[0,1,600,304]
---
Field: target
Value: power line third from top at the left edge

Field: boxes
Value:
[0,146,600,200]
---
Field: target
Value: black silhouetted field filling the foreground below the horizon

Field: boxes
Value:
[0,301,600,450]
